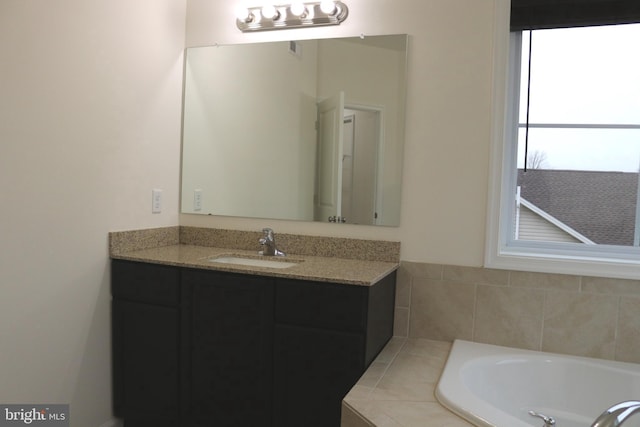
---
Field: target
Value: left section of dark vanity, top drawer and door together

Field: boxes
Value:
[111,261,181,427]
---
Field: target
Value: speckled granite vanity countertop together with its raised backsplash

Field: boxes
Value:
[110,228,399,286]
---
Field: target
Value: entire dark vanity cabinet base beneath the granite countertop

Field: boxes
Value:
[112,260,395,427]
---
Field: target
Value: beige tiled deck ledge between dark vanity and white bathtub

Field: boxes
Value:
[341,337,473,427]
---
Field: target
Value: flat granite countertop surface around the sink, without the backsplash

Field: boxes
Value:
[111,244,398,286]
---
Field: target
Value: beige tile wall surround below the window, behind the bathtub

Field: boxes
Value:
[394,261,640,363]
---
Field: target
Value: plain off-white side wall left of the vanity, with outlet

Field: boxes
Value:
[0,0,186,427]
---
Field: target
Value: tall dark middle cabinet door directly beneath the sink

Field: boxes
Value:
[183,270,273,427]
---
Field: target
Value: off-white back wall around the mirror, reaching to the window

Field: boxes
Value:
[180,0,500,266]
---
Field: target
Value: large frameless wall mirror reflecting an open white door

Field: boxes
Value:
[181,35,407,226]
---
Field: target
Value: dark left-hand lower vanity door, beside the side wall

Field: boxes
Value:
[112,299,179,427]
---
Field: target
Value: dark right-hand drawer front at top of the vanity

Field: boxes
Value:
[275,279,368,332]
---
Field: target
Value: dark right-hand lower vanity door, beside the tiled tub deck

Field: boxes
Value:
[274,325,365,427]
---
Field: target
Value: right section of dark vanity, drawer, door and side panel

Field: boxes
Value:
[274,274,395,427]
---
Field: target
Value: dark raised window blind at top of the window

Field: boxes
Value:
[511,0,640,31]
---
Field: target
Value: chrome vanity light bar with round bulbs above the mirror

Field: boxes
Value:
[236,0,349,32]
